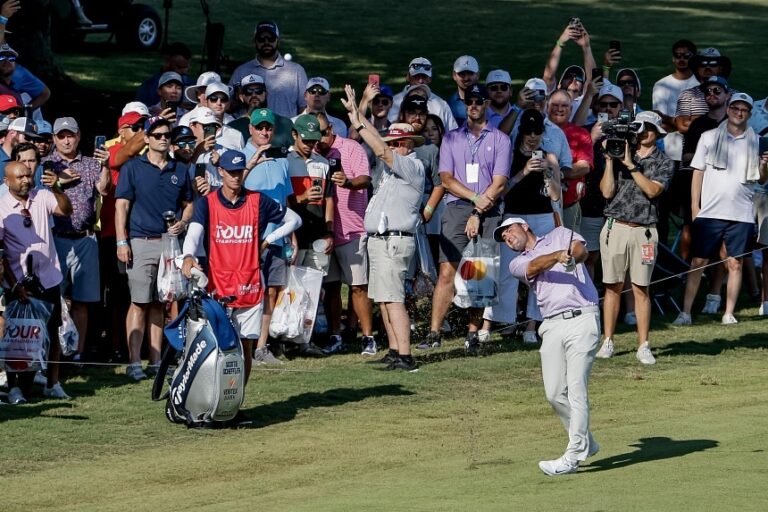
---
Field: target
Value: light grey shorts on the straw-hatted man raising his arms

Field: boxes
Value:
[368,236,416,303]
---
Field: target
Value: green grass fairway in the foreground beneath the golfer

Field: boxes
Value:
[0,310,768,512]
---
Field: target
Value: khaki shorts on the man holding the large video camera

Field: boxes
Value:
[600,221,659,286]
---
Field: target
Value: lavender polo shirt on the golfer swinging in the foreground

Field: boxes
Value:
[509,226,599,318]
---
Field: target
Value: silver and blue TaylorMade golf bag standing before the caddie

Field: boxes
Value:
[152,273,245,428]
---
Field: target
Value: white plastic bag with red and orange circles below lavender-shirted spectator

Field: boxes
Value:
[453,238,499,308]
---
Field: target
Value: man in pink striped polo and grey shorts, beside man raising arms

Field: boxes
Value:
[316,113,377,355]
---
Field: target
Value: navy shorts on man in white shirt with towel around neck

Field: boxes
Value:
[691,217,755,260]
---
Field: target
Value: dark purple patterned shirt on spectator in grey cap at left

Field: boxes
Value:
[43,151,101,234]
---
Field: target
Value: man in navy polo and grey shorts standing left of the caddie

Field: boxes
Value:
[115,117,192,381]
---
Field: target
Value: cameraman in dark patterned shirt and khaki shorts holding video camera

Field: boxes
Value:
[596,111,673,364]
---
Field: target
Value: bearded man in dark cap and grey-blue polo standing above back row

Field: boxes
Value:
[229,21,307,117]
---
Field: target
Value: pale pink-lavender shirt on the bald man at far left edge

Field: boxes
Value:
[0,189,62,289]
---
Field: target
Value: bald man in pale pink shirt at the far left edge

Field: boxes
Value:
[0,162,72,404]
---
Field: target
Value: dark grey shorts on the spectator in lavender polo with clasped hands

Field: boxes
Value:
[439,201,501,263]
